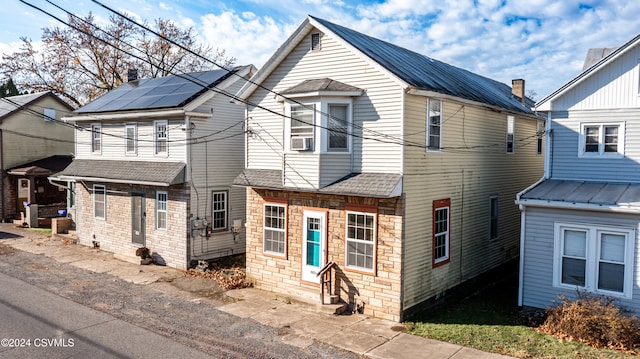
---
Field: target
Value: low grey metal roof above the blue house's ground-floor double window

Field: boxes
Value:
[520,180,640,207]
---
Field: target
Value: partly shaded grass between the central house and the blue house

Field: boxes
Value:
[405,276,637,359]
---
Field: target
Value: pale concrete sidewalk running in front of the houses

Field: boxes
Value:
[0,223,509,359]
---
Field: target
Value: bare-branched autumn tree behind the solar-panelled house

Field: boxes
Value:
[0,14,235,106]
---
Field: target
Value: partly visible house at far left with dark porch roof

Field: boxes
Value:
[0,92,74,221]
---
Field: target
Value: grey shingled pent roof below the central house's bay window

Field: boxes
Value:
[233,169,402,198]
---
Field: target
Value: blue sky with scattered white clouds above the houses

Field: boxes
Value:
[0,0,640,100]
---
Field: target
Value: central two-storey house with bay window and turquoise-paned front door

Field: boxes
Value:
[234,16,543,321]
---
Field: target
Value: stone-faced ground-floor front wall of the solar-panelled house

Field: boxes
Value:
[76,182,189,269]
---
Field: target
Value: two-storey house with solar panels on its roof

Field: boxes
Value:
[55,66,255,269]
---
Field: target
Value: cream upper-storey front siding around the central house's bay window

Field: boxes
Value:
[247,31,402,176]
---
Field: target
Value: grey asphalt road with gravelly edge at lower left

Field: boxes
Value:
[0,238,358,359]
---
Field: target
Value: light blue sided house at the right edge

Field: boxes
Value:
[516,35,640,312]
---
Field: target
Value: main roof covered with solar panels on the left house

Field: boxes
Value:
[75,70,234,113]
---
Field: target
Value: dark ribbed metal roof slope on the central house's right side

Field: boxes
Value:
[310,16,534,113]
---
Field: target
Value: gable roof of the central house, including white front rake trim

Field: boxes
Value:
[240,15,533,114]
